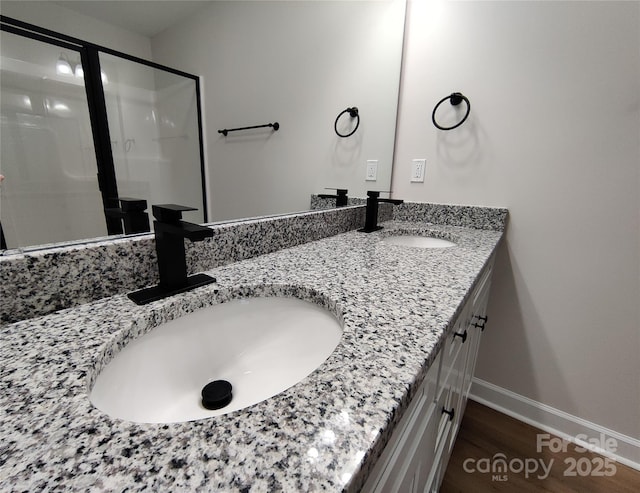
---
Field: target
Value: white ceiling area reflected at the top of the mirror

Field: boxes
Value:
[54,0,210,38]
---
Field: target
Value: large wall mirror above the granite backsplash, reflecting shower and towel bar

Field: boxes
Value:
[0,0,406,252]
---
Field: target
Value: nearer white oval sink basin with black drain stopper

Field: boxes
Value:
[89,297,342,423]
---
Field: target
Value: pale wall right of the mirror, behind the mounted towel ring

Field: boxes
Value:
[393,0,640,444]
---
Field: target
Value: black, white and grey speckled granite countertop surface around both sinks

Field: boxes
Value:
[0,221,502,491]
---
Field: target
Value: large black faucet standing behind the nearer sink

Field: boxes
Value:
[128,204,215,305]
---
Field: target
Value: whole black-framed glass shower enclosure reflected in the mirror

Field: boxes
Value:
[0,17,207,249]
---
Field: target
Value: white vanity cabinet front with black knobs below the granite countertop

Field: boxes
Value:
[362,259,493,493]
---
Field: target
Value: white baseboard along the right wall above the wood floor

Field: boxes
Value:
[469,378,640,471]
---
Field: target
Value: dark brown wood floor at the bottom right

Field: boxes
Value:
[440,400,640,493]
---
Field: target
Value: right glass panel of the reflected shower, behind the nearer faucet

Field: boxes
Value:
[100,53,204,223]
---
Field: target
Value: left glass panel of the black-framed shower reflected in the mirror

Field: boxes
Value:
[0,31,107,248]
